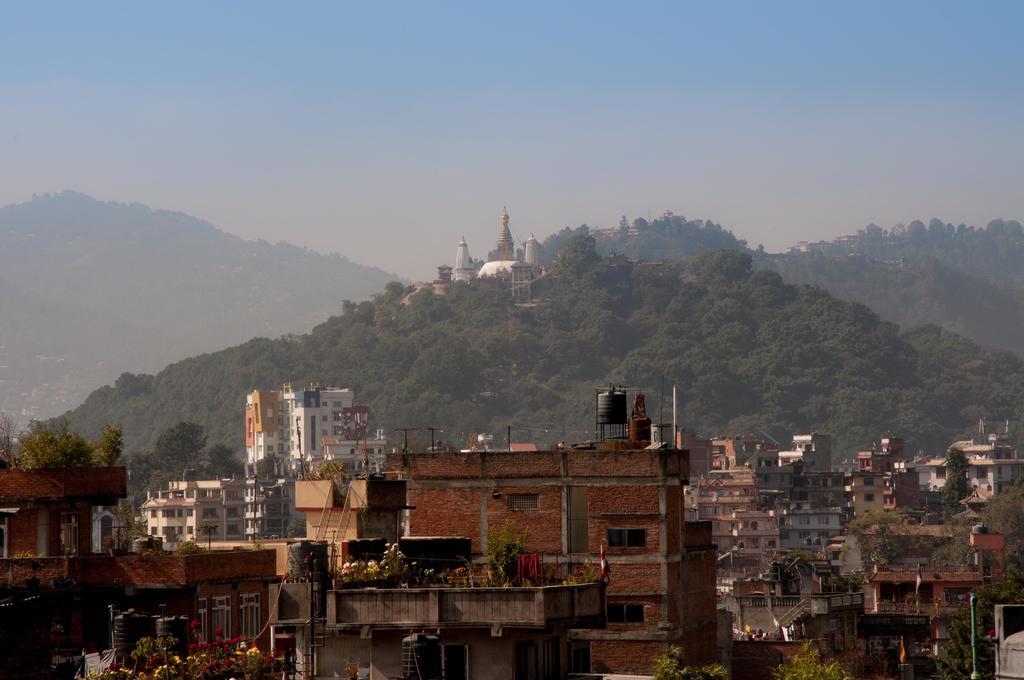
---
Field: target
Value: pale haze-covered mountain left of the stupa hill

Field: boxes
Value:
[0,192,398,421]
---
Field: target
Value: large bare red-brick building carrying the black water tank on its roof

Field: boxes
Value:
[388,442,716,673]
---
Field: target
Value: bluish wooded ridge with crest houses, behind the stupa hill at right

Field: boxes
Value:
[561,215,1024,356]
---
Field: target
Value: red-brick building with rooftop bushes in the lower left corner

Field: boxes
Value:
[0,467,278,677]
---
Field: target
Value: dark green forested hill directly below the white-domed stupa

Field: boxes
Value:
[59,237,1024,464]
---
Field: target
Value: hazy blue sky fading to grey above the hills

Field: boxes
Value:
[0,0,1024,278]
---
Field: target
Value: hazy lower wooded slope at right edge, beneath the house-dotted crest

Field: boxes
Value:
[759,253,1024,356]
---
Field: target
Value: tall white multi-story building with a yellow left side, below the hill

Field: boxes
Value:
[246,384,386,473]
